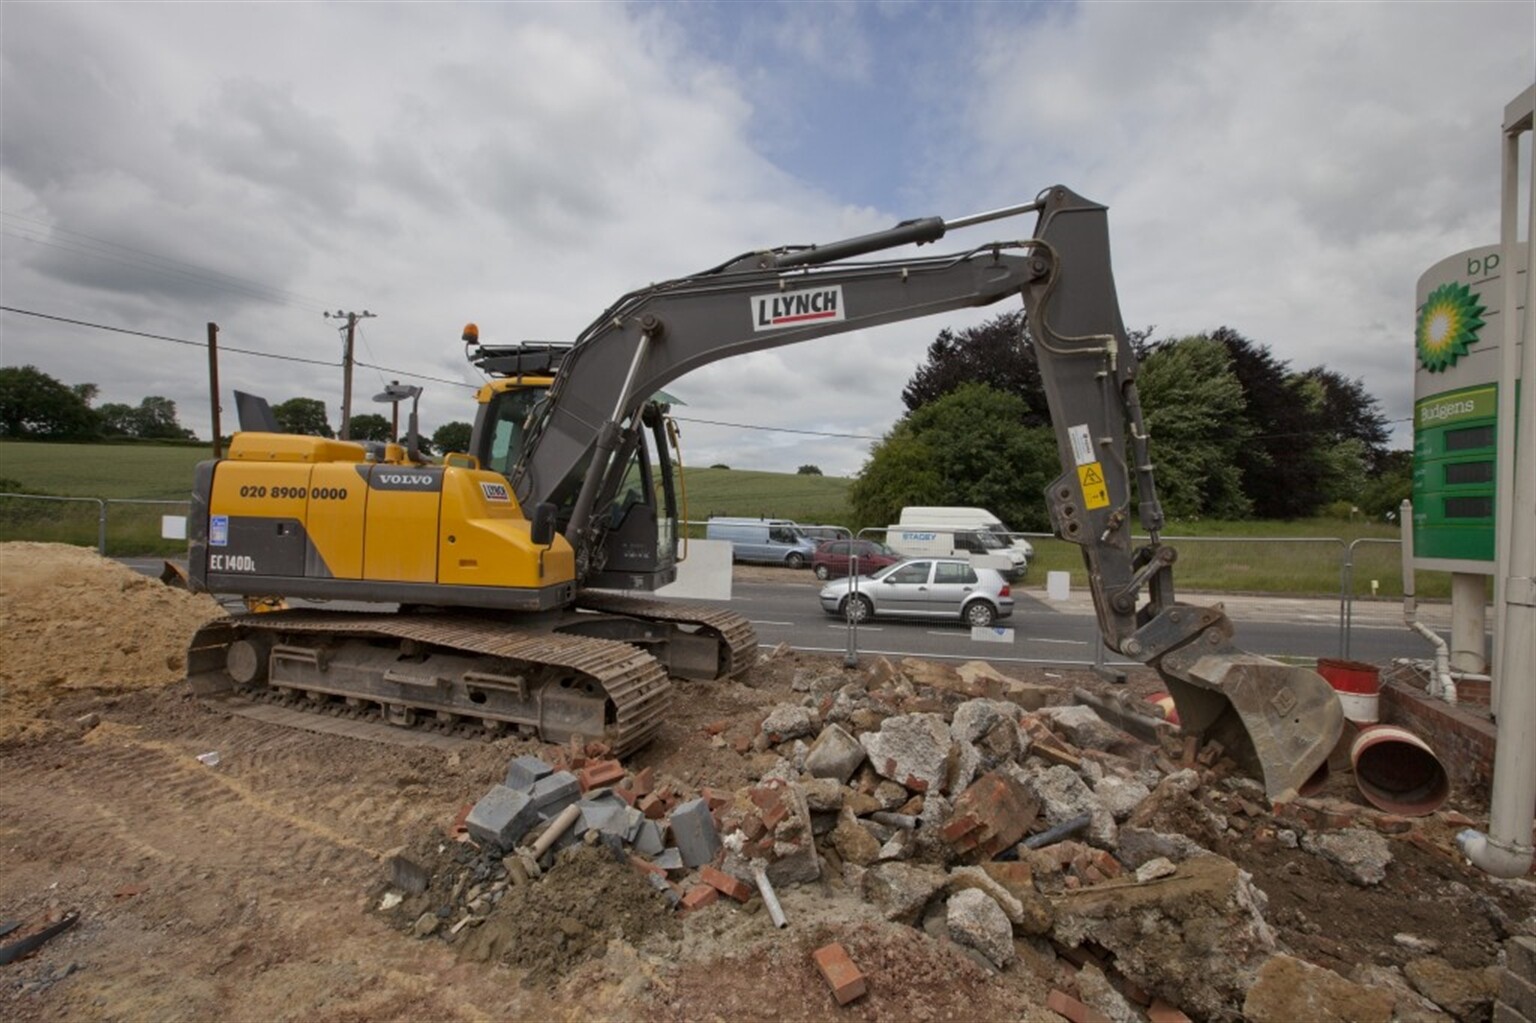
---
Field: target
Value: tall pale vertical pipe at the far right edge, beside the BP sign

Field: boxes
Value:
[1456,84,1536,877]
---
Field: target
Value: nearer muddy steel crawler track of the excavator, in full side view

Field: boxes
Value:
[187,610,671,756]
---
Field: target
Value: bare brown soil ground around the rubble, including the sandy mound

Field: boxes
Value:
[0,544,1533,1020]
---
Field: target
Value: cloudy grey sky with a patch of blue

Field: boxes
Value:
[0,0,1536,475]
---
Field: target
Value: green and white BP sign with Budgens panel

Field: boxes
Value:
[1413,246,1524,573]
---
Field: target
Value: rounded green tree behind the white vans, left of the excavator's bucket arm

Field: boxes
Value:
[848,382,1061,530]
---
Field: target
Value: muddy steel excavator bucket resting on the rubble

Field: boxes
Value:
[1157,648,1344,802]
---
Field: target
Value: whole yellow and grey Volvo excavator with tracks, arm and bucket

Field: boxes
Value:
[187,186,1342,800]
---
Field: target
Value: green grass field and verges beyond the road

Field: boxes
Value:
[0,441,1450,598]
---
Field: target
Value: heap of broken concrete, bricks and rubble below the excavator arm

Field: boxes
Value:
[374,659,1511,1021]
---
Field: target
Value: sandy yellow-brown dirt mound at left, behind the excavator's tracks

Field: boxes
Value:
[0,544,223,736]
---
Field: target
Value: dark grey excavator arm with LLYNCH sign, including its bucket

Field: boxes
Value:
[497,187,1342,800]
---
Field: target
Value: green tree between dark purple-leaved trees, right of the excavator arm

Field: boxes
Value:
[1137,336,1252,519]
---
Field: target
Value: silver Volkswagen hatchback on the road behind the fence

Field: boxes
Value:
[822,558,1014,627]
